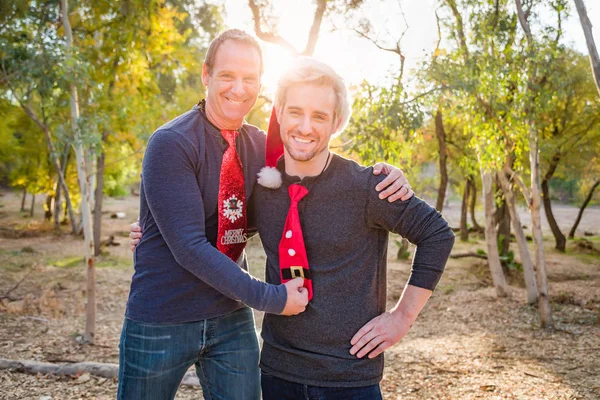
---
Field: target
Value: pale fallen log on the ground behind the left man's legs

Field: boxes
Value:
[0,358,200,386]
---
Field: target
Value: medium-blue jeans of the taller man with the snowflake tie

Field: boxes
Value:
[117,308,260,400]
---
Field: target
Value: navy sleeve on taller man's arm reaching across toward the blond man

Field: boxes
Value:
[142,130,287,314]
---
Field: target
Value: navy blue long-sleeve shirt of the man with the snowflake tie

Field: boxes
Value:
[125,106,286,323]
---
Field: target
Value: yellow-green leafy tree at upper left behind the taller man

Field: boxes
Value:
[0,0,222,341]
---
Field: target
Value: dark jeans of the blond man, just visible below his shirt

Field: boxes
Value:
[261,372,382,400]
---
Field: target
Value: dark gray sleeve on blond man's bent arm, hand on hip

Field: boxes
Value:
[365,170,454,290]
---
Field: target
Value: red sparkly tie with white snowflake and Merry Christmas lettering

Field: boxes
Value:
[217,130,248,262]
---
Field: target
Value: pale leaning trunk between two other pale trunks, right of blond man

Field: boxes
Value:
[498,171,538,304]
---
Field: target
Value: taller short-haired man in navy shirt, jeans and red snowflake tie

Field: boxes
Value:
[118,30,412,400]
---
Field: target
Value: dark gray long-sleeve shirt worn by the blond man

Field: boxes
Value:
[252,155,454,387]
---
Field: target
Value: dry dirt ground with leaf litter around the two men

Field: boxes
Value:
[0,188,600,400]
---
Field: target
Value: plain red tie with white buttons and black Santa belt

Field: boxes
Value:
[279,184,313,300]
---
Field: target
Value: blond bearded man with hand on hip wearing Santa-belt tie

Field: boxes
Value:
[252,58,454,400]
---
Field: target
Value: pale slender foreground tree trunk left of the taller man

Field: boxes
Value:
[61,0,96,343]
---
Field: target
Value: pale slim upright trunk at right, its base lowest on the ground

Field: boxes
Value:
[529,131,553,328]
